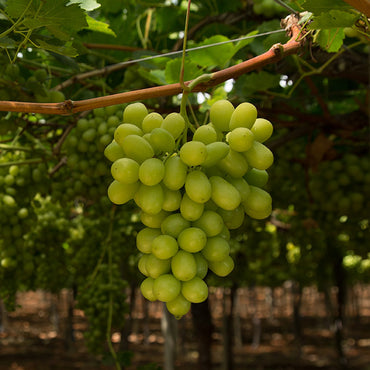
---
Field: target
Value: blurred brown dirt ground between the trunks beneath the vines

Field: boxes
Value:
[0,287,370,370]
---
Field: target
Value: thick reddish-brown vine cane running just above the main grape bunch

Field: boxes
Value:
[0,15,303,115]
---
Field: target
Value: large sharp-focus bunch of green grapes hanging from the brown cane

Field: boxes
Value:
[105,100,273,317]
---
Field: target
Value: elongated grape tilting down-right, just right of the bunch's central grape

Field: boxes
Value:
[209,176,241,211]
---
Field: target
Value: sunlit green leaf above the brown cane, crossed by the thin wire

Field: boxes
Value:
[190,35,235,67]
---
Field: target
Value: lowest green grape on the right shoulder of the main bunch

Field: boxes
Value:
[243,186,272,220]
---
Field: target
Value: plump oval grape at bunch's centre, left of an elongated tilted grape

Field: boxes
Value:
[185,170,212,203]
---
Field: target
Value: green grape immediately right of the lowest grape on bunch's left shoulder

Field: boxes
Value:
[134,184,163,215]
